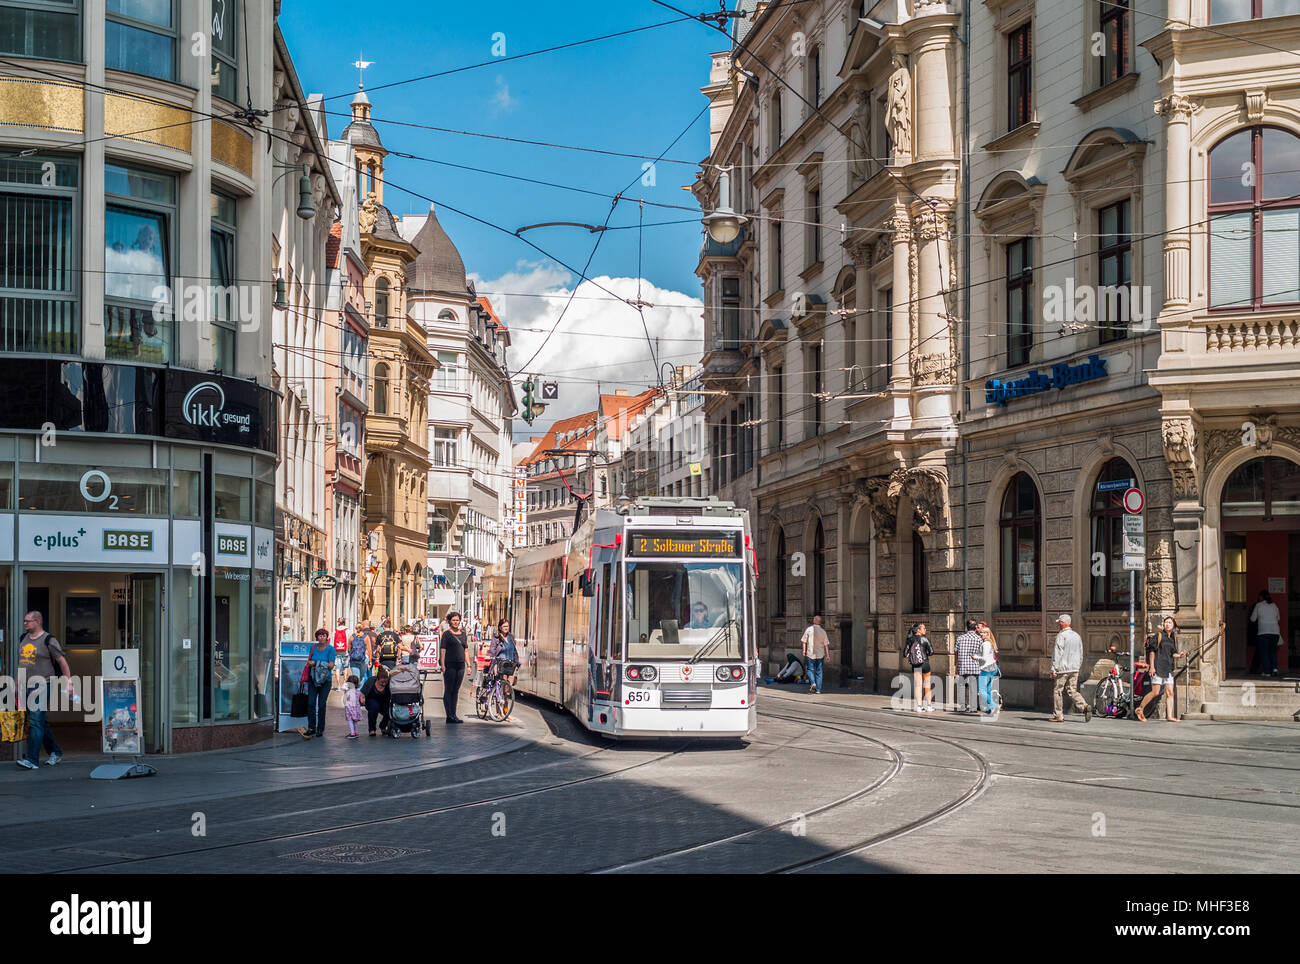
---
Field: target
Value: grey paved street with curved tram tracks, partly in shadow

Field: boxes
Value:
[0,687,1300,873]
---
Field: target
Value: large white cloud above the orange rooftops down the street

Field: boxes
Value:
[471,261,703,438]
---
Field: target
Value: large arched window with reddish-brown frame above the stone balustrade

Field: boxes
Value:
[1209,127,1300,312]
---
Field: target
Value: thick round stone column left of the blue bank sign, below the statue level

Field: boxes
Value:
[911,200,953,420]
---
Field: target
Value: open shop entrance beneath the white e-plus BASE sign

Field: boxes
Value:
[22,570,165,754]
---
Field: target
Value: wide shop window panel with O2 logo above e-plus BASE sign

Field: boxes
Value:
[18,463,170,516]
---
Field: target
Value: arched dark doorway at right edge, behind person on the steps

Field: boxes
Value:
[1222,456,1300,678]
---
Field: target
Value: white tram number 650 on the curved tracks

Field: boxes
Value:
[488,498,758,738]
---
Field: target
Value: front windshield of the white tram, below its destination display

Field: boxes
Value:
[625,561,745,660]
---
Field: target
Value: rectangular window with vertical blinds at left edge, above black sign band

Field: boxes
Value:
[0,155,81,355]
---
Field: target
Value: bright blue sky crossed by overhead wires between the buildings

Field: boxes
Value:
[280,0,725,296]
